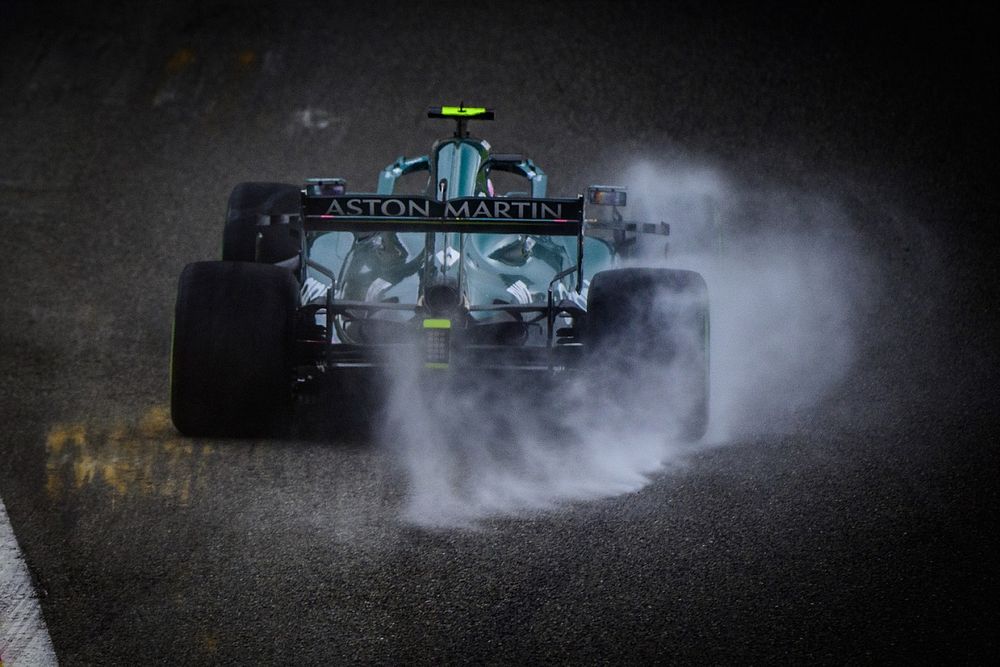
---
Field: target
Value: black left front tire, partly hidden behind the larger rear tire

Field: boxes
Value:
[222,183,302,264]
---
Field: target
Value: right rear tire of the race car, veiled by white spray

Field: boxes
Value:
[586,269,709,440]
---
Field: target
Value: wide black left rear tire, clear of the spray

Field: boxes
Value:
[170,262,298,436]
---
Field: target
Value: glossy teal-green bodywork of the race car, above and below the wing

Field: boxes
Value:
[306,116,615,345]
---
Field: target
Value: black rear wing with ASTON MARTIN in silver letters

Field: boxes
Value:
[302,190,583,236]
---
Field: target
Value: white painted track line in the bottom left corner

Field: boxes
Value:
[0,500,57,667]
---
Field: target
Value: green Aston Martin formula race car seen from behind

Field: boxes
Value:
[170,106,709,439]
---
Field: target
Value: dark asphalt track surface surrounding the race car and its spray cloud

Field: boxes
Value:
[0,2,1000,664]
